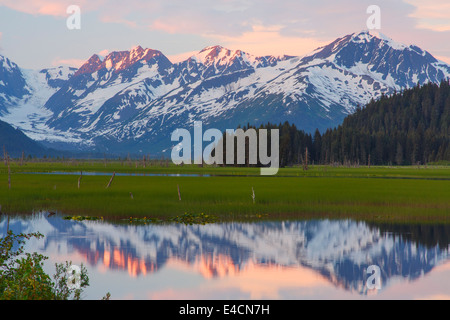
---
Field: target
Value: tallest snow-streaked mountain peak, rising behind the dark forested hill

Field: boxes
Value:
[221,32,450,132]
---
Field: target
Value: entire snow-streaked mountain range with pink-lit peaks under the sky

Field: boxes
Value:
[0,31,450,155]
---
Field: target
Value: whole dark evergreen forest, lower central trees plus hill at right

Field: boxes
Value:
[224,81,450,167]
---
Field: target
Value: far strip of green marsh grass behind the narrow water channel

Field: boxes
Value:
[0,160,450,180]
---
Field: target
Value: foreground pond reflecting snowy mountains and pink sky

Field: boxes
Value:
[0,213,450,300]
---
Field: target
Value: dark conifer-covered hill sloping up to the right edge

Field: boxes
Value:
[316,81,450,165]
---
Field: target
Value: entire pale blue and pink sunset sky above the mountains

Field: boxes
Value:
[0,0,450,69]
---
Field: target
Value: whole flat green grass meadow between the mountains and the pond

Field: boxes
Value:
[0,161,450,223]
